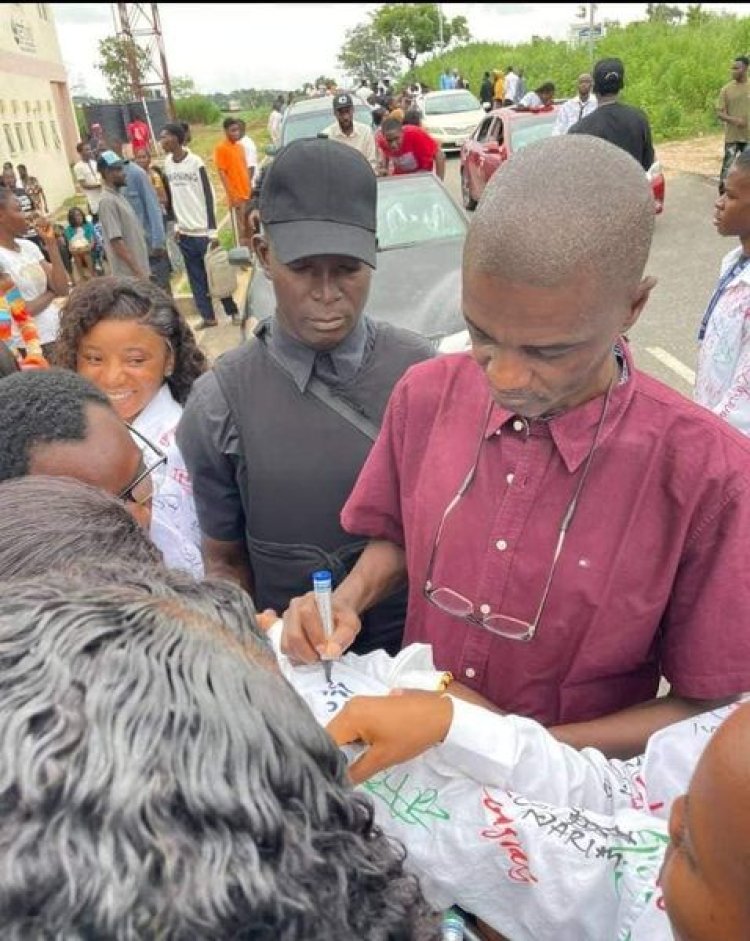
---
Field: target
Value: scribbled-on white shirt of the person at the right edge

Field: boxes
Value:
[695,247,750,435]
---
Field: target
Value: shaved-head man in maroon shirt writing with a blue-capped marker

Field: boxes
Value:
[285,135,750,756]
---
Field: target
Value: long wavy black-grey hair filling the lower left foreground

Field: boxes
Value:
[0,571,439,941]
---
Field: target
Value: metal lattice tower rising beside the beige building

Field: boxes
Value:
[112,3,174,120]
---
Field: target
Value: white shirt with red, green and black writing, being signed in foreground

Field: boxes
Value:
[271,629,734,941]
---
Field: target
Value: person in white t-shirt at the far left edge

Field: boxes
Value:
[0,186,69,359]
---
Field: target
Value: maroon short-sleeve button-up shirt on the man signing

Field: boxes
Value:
[342,354,750,725]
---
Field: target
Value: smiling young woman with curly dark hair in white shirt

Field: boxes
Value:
[55,277,207,576]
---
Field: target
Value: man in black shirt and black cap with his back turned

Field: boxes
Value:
[568,59,655,170]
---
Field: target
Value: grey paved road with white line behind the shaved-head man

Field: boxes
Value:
[445,156,733,395]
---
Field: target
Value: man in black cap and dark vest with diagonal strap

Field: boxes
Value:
[177,138,432,652]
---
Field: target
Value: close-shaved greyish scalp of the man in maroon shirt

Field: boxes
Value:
[464,134,654,289]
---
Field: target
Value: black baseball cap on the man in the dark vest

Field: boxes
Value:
[260,138,378,268]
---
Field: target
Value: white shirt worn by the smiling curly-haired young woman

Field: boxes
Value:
[132,383,203,578]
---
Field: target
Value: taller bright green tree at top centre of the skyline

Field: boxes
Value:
[372,3,471,69]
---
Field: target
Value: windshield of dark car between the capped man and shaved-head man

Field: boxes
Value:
[377,175,466,251]
